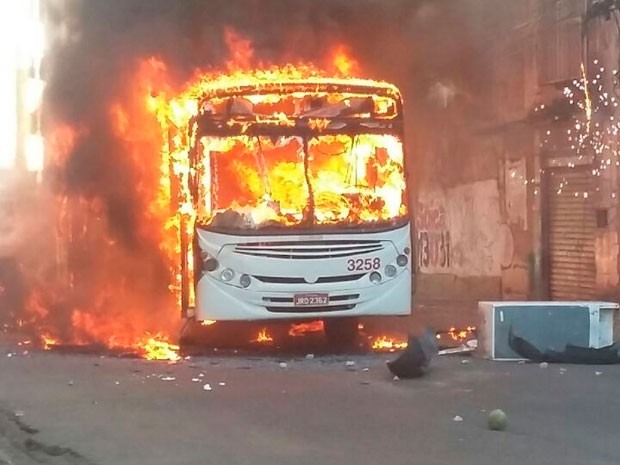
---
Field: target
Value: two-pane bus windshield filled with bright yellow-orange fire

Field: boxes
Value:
[195,132,407,233]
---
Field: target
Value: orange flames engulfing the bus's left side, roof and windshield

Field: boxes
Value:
[20,29,398,360]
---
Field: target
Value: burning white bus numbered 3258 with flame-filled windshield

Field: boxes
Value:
[187,79,411,320]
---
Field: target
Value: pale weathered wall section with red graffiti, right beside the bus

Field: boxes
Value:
[415,179,505,300]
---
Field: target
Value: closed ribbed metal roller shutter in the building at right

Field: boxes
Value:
[547,167,596,300]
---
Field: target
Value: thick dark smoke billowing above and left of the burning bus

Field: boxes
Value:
[2,0,484,340]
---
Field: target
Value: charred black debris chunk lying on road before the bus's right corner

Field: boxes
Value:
[387,330,437,379]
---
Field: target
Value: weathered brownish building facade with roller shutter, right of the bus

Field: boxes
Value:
[414,0,620,322]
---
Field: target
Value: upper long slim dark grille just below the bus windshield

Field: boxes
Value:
[235,240,383,260]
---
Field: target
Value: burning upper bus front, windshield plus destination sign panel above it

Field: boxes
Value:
[191,80,407,229]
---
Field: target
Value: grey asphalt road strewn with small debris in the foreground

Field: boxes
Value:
[0,345,620,465]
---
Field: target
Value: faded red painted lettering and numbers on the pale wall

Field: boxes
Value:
[415,203,452,271]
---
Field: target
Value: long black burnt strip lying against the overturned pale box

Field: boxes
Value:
[508,328,620,365]
